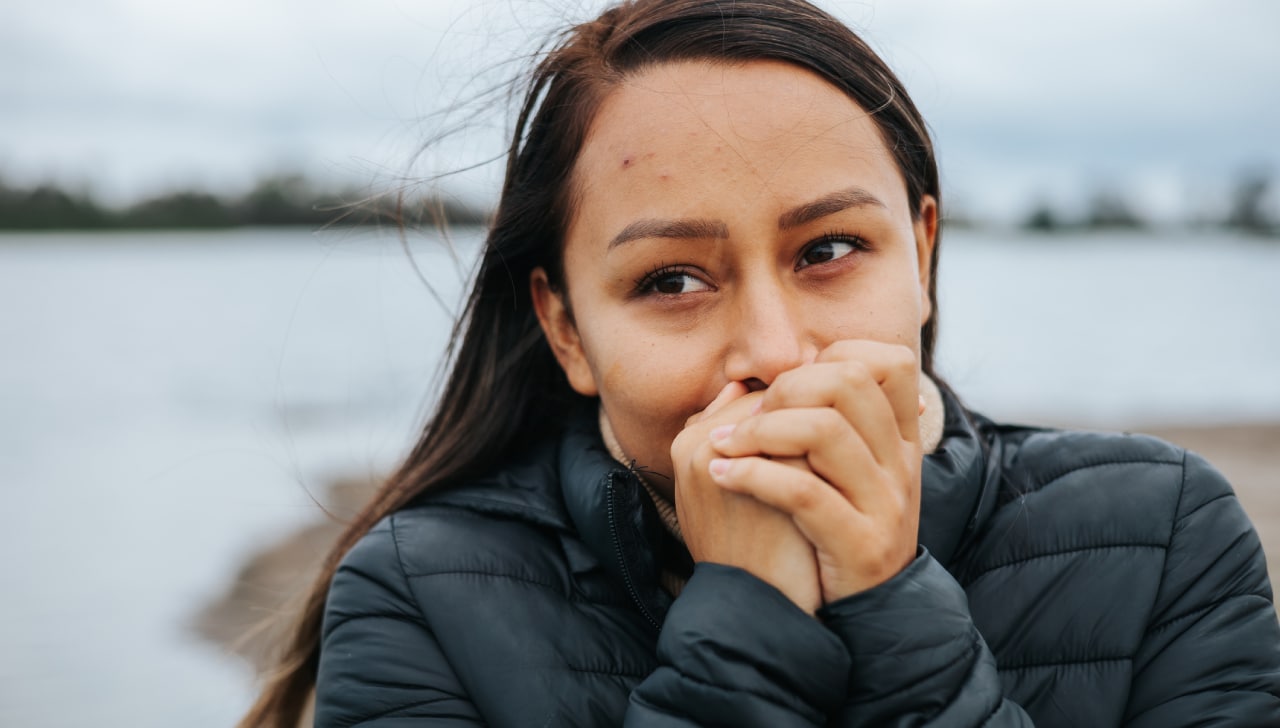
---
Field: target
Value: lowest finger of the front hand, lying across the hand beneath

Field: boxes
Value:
[709,457,867,554]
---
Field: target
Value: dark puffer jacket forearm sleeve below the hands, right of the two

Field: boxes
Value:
[818,548,1032,728]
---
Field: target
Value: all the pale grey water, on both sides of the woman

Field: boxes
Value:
[0,225,1280,727]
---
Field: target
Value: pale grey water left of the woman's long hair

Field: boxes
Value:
[0,232,471,727]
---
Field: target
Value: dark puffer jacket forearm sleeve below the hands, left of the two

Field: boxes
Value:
[625,563,849,728]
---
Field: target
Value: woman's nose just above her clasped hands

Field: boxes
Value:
[724,273,818,392]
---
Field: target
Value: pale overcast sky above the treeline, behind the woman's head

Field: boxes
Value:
[0,0,1280,219]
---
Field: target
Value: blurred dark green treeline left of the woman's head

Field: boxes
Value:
[0,174,489,230]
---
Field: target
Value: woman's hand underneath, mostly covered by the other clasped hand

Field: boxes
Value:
[671,381,822,614]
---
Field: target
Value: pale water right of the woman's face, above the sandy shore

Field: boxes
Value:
[938,233,1280,427]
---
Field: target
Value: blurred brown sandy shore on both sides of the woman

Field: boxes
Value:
[192,422,1280,668]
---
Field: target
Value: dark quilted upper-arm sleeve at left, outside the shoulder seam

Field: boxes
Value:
[315,519,484,728]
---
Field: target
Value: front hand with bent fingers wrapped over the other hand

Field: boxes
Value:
[708,340,922,603]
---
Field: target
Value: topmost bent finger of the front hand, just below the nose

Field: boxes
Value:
[762,361,901,464]
